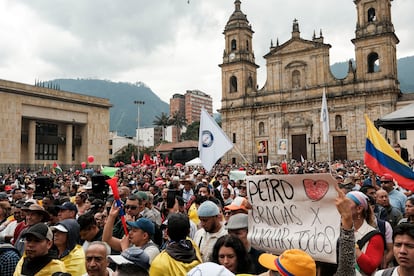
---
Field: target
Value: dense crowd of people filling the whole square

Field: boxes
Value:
[0,161,414,276]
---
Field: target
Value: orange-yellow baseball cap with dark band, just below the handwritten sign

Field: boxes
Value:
[259,249,316,276]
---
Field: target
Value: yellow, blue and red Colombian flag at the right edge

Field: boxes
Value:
[364,114,414,191]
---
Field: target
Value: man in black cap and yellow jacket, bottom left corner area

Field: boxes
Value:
[13,223,66,276]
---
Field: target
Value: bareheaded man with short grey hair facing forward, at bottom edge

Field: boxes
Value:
[83,241,114,276]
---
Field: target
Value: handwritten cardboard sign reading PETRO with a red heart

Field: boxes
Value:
[246,174,340,263]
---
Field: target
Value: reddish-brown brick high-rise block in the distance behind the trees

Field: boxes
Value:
[170,90,213,142]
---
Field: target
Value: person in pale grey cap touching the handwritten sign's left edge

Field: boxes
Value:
[226,213,266,274]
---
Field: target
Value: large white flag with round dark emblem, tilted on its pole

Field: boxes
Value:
[198,108,233,171]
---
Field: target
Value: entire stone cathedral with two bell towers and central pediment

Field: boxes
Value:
[220,0,406,162]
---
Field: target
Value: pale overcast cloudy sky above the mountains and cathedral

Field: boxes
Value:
[0,0,414,109]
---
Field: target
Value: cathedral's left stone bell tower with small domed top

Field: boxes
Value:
[219,0,259,109]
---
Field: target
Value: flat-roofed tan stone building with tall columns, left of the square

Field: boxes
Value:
[0,80,112,171]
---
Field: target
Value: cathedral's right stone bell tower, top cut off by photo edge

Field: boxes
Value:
[352,0,399,81]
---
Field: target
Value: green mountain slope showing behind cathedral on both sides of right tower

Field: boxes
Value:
[331,56,414,93]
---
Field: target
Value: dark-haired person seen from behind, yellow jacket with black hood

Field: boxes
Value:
[149,213,202,276]
